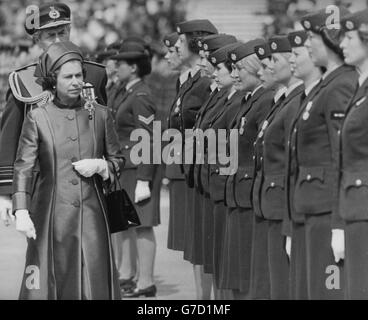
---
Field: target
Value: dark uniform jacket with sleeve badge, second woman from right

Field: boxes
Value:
[290,65,358,227]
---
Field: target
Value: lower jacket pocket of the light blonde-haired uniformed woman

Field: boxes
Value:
[235,167,254,208]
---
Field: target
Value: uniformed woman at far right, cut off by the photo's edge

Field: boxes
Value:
[339,9,368,300]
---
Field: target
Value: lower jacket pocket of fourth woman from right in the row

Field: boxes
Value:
[261,174,286,220]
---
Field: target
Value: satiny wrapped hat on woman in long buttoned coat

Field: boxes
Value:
[35,41,84,77]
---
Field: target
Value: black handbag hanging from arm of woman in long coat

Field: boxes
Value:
[106,165,141,233]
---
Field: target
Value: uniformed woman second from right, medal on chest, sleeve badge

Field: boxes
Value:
[291,8,357,299]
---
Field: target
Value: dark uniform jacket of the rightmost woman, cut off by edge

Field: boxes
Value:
[339,80,368,221]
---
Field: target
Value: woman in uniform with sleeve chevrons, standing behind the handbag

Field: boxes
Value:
[111,41,160,297]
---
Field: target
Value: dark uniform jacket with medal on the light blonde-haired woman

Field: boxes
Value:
[226,87,274,208]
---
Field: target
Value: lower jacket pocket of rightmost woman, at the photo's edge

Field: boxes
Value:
[339,172,368,221]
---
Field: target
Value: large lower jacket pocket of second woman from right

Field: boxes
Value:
[294,167,337,214]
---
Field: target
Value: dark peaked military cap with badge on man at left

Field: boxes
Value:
[24,3,71,35]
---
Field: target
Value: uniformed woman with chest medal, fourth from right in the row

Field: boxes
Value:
[253,36,304,300]
